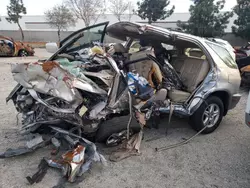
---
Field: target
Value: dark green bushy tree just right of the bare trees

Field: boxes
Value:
[136,0,175,24]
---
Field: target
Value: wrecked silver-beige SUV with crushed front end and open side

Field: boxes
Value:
[7,22,241,145]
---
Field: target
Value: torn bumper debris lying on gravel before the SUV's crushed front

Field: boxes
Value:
[0,126,106,184]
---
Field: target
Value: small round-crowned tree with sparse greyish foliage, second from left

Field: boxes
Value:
[44,5,76,42]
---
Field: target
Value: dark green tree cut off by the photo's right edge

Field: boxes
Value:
[232,0,250,40]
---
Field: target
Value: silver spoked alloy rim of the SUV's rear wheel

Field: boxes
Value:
[202,104,220,128]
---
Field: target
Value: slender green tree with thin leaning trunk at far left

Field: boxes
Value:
[6,0,27,40]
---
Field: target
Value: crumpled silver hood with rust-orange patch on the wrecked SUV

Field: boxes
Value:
[11,61,82,104]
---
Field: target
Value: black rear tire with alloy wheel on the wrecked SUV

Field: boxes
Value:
[189,96,224,134]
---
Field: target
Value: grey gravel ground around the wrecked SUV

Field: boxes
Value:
[0,49,250,188]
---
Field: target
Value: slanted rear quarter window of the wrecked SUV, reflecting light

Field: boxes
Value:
[207,42,238,69]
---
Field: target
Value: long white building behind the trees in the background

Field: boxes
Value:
[0,13,236,33]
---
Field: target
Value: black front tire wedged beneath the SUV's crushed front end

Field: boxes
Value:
[95,116,141,142]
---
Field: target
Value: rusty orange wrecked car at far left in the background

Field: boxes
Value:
[0,35,35,57]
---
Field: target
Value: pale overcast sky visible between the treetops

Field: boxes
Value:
[0,0,236,16]
